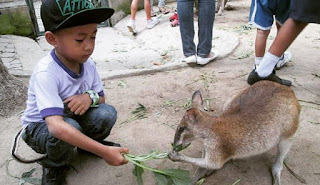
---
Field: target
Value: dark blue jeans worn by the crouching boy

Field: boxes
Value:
[22,104,117,168]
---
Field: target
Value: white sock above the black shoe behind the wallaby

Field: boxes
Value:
[256,52,280,77]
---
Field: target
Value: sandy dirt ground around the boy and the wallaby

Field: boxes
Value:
[0,0,320,185]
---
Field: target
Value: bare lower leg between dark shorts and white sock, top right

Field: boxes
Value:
[269,18,308,57]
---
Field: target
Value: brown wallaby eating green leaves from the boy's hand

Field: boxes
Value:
[169,81,300,185]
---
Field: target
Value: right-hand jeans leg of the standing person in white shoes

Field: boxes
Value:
[195,0,215,58]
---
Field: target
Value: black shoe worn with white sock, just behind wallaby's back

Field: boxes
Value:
[247,70,292,86]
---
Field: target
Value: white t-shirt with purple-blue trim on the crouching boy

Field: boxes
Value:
[21,50,104,124]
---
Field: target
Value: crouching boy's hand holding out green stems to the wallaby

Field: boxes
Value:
[101,146,129,166]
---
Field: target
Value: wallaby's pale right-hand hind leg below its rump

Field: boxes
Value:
[272,139,292,185]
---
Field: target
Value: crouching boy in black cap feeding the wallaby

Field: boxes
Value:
[22,0,129,185]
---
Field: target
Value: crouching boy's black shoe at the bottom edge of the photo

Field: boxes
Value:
[41,166,70,185]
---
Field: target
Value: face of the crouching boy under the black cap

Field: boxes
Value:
[53,24,97,64]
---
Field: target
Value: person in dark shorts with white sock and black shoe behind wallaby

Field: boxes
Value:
[247,0,320,86]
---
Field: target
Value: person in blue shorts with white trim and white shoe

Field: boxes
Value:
[249,0,291,69]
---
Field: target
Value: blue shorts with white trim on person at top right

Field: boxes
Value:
[249,0,290,30]
